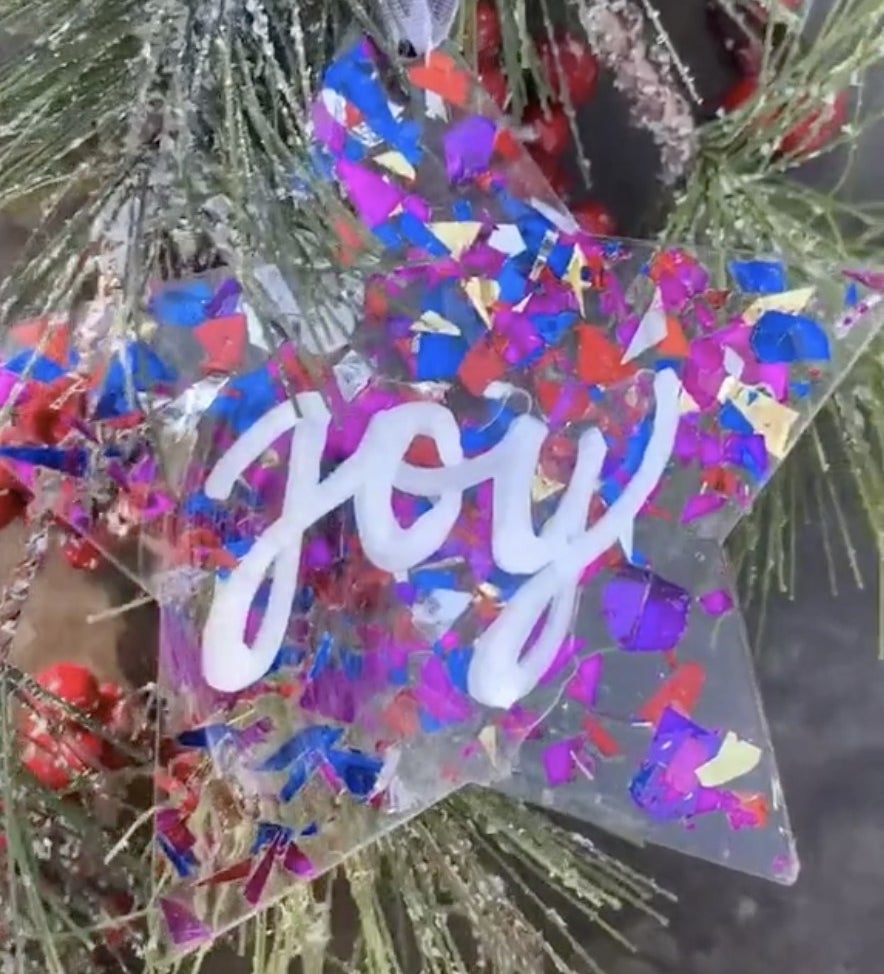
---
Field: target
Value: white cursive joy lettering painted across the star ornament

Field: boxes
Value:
[202,369,681,707]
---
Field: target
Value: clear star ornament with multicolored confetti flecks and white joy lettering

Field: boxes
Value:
[0,41,884,950]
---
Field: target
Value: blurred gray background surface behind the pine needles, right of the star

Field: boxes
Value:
[592,0,884,974]
